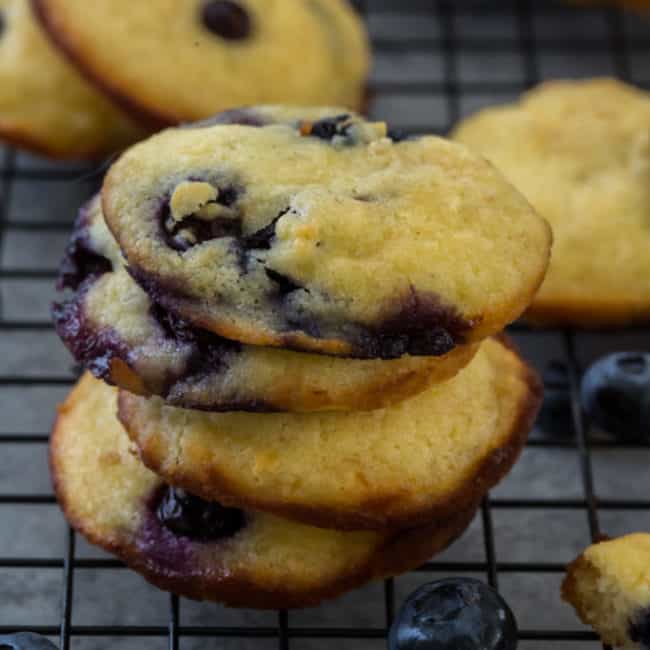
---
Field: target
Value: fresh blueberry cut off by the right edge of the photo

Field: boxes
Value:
[582,352,650,442]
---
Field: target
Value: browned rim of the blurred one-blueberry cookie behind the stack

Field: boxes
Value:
[29,0,372,130]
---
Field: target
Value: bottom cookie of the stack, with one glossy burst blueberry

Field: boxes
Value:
[50,374,473,609]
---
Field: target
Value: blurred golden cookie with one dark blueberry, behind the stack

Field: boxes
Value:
[33,0,370,125]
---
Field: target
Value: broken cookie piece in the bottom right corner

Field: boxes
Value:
[562,533,650,650]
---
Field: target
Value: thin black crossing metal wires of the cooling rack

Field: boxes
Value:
[0,0,650,650]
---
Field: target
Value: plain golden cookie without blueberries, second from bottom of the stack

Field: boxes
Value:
[119,340,541,529]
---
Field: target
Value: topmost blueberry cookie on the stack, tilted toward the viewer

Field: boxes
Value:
[103,113,551,359]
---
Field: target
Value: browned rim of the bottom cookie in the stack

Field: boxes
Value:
[49,375,476,609]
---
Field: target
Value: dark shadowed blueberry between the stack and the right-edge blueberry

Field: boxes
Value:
[535,361,575,437]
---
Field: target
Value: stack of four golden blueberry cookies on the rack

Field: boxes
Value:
[51,106,550,608]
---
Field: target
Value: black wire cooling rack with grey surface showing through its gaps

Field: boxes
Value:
[0,0,650,650]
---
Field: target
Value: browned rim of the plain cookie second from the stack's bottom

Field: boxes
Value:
[118,335,543,530]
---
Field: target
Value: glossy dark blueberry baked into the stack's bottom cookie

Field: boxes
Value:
[156,486,246,542]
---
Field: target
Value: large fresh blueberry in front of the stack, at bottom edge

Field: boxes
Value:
[388,578,517,650]
